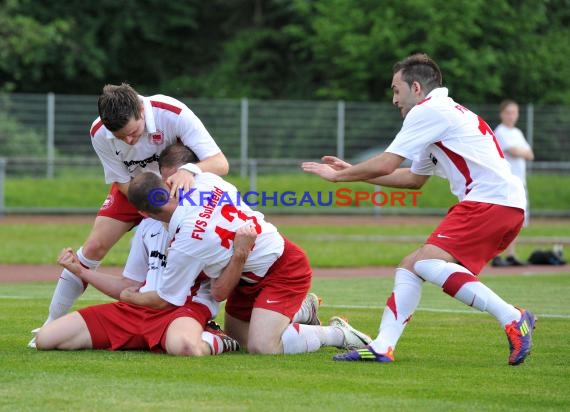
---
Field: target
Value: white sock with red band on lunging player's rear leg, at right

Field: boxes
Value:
[414,259,521,327]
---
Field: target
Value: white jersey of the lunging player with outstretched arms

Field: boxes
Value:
[386,87,526,210]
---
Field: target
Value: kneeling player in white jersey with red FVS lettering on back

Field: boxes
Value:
[122,145,371,354]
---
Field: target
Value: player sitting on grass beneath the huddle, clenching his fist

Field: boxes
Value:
[36,219,240,356]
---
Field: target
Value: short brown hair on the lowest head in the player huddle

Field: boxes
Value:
[127,172,165,214]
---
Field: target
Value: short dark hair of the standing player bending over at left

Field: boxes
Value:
[97,83,142,132]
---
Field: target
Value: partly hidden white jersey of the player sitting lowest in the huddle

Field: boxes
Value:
[123,218,219,317]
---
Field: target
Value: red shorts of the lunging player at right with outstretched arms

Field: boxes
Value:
[426,201,524,275]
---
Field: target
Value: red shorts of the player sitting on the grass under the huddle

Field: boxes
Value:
[78,301,212,353]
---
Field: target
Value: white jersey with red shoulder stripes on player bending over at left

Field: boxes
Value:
[91,94,221,184]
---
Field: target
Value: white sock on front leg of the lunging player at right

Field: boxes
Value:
[370,268,423,353]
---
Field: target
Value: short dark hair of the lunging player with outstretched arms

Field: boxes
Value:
[392,53,443,94]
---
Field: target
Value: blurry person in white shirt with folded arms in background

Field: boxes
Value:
[492,100,534,266]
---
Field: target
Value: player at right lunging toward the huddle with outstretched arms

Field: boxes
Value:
[302,54,536,365]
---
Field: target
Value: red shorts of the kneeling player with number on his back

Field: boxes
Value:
[225,239,313,322]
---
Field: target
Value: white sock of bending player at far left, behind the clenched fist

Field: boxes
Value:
[44,248,101,325]
